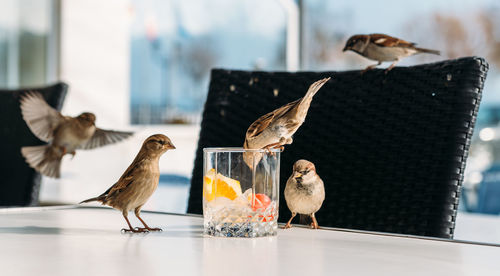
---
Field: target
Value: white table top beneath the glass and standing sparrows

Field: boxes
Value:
[0,208,500,276]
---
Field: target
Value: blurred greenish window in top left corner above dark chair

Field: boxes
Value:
[0,0,58,88]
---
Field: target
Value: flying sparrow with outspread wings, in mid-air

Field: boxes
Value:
[20,92,133,178]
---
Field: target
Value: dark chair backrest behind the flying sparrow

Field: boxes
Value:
[0,83,68,206]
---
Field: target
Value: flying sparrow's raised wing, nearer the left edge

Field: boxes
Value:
[20,92,65,142]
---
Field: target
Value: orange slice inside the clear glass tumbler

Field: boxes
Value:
[203,169,242,201]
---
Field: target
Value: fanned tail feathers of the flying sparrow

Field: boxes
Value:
[21,145,62,178]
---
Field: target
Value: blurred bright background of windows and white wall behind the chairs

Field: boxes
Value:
[0,0,500,242]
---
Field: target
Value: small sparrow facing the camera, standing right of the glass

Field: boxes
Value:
[284,159,325,229]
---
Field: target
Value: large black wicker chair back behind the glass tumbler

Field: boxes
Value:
[188,57,488,238]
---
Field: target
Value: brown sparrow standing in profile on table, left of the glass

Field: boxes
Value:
[80,134,175,233]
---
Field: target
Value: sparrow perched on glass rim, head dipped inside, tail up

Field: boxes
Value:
[243,78,330,168]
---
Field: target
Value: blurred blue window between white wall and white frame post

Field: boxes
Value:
[130,0,286,124]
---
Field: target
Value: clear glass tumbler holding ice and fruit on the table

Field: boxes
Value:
[203,148,280,237]
